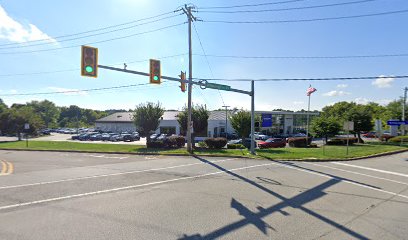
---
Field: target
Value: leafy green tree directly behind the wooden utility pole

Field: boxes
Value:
[177,105,210,136]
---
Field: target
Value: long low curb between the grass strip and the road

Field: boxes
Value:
[0,148,408,162]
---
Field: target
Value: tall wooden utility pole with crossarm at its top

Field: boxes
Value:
[182,4,197,153]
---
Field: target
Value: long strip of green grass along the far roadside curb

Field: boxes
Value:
[0,141,408,160]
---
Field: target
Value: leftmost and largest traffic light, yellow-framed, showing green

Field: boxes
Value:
[81,46,98,78]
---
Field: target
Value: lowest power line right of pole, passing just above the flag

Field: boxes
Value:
[195,75,408,82]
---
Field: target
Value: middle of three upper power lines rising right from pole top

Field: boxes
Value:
[199,0,377,14]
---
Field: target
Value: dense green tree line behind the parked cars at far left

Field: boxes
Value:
[0,99,109,135]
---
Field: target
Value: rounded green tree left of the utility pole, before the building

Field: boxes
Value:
[133,102,164,141]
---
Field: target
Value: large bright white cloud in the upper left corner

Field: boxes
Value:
[0,6,57,43]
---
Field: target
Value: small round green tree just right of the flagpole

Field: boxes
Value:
[311,117,341,142]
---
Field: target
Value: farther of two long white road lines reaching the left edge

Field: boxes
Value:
[0,158,236,190]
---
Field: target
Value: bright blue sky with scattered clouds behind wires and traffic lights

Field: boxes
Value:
[0,0,408,111]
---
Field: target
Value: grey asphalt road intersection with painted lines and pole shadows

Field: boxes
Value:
[0,151,408,240]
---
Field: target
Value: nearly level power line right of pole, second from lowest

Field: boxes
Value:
[194,53,408,59]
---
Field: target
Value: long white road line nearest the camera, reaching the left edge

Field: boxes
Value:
[0,163,275,210]
